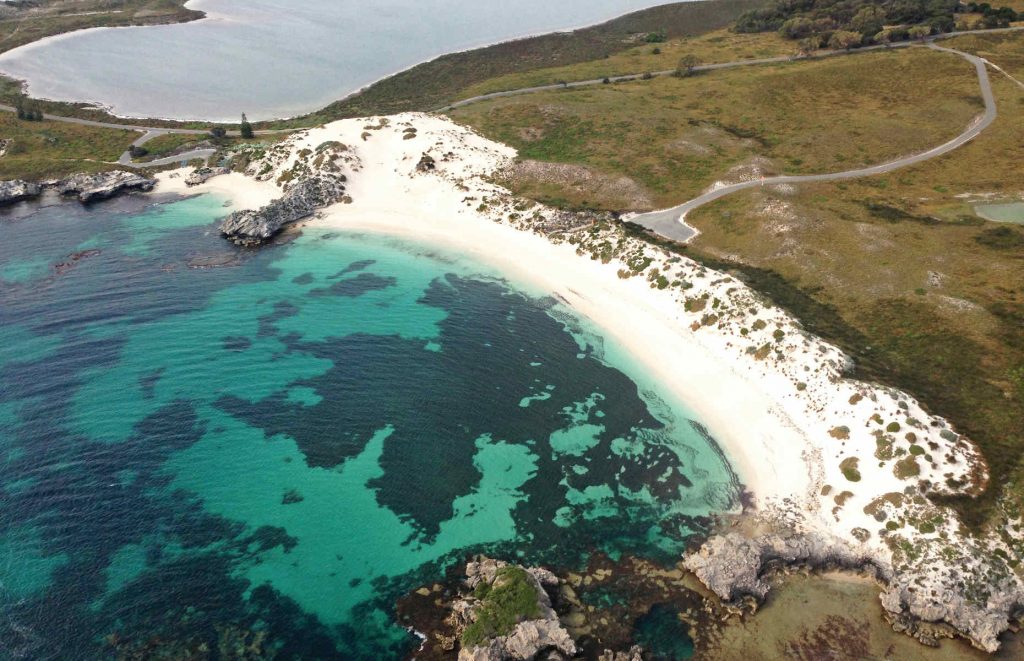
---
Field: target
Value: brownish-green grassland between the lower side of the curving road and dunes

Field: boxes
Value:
[688,41,1024,523]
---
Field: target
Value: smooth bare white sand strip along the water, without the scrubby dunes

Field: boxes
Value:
[158,119,811,503]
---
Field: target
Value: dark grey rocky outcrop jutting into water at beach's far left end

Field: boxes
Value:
[220,174,345,246]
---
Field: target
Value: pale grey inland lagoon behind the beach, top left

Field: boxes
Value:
[0,0,665,121]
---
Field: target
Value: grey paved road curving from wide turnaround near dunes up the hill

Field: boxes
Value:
[627,41,996,241]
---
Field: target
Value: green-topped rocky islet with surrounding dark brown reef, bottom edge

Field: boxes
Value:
[397,556,663,661]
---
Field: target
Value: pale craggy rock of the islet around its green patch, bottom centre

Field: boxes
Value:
[452,558,577,661]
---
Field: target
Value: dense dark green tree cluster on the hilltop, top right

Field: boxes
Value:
[734,0,1021,51]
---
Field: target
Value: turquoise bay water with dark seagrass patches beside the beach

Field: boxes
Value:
[0,196,738,659]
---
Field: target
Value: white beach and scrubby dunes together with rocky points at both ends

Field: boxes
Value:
[174,114,1024,652]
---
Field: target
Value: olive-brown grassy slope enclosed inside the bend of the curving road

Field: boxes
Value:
[452,48,982,211]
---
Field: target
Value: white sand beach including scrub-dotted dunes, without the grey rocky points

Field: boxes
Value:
[167,114,1024,650]
